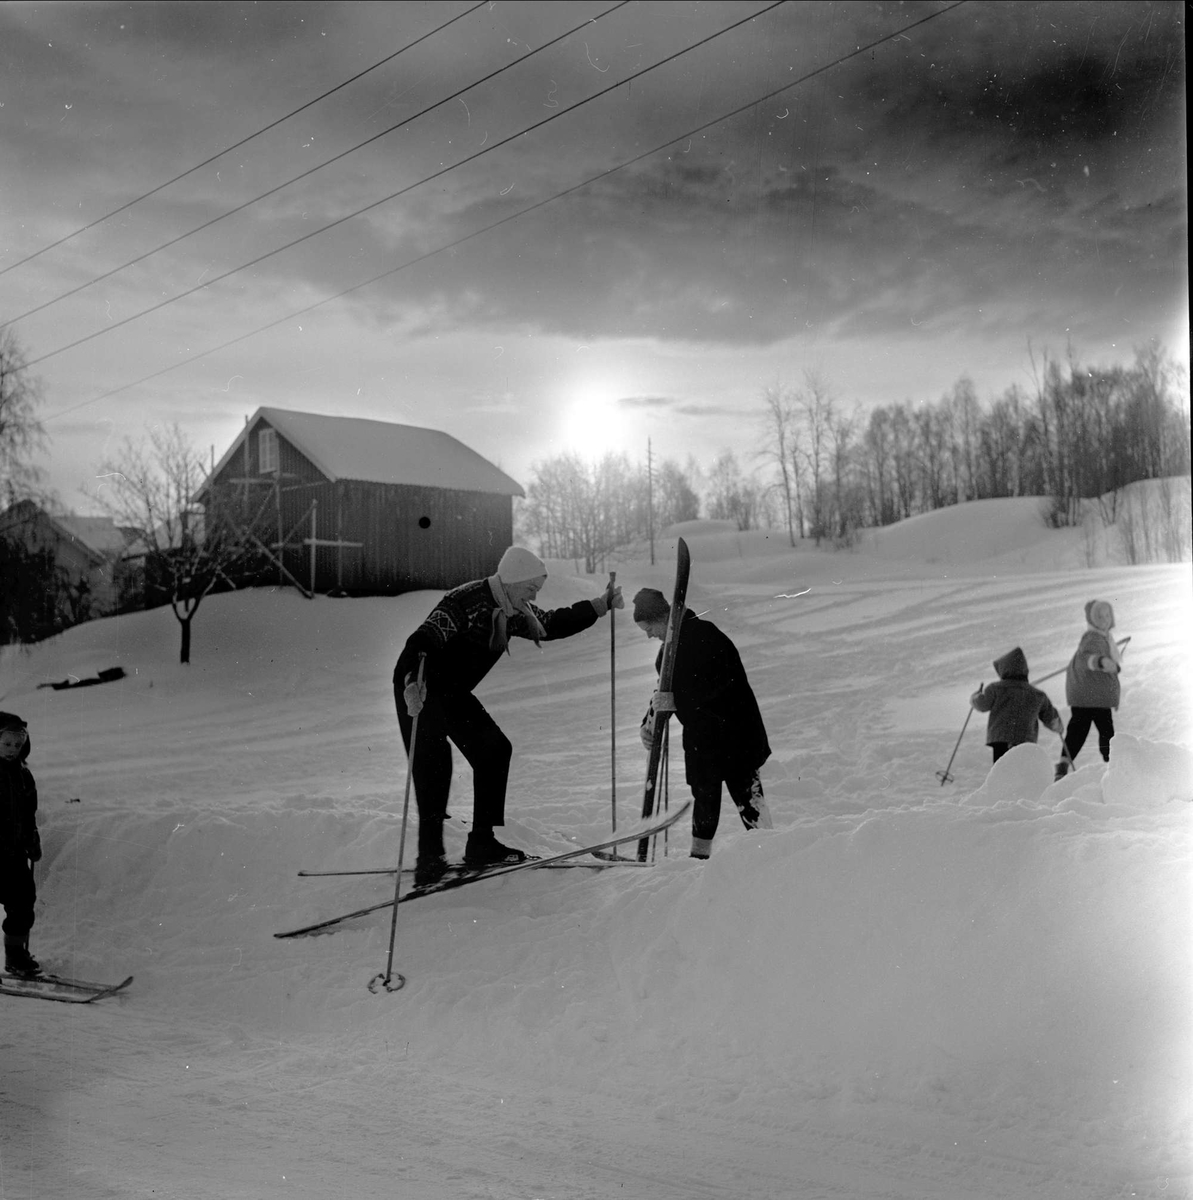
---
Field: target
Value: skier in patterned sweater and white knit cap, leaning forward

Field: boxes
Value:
[394,546,624,887]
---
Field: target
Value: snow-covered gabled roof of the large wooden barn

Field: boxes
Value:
[203,407,526,496]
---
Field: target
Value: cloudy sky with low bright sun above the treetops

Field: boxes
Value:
[0,0,1188,511]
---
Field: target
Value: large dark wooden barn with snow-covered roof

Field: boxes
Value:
[196,408,524,595]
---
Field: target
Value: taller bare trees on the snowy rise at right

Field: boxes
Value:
[762,348,1189,541]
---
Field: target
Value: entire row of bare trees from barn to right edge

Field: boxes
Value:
[520,348,1189,571]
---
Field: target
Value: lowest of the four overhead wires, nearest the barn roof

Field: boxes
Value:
[46,0,966,421]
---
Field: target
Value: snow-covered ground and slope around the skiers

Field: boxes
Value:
[0,500,1193,1200]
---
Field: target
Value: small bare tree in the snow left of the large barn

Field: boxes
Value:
[94,424,245,662]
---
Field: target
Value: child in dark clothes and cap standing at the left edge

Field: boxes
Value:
[0,713,42,976]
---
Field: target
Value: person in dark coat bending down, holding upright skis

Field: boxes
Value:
[634,588,772,858]
